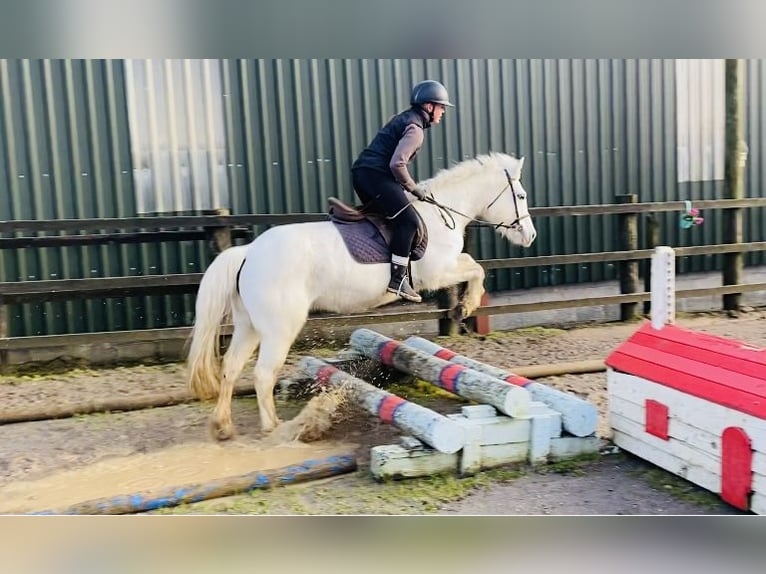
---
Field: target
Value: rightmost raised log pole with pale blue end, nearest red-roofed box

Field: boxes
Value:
[404,337,598,437]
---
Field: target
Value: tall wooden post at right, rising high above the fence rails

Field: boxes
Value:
[722,60,747,313]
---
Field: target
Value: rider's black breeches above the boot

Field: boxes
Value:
[352,169,418,257]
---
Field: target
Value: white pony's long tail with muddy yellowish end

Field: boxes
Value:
[186,245,247,399]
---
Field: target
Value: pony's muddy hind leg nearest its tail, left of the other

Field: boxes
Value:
[210,318,259,440]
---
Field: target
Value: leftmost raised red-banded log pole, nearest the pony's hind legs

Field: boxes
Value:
[298,357,465,454]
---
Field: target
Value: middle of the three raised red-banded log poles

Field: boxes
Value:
[350,329,531,417]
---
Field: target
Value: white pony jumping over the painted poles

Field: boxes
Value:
[187,153,537,440]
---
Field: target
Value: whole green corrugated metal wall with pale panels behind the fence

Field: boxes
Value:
[0,59,766,334]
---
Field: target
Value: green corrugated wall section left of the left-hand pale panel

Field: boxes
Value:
[0,60,198,335]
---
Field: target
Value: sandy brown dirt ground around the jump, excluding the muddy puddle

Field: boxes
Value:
[0,310,766,515]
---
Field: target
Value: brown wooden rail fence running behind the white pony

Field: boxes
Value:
[0,196,766,365]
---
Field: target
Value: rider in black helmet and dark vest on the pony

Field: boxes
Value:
[351,80,453,303]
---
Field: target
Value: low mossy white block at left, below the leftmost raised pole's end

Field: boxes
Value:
[370,444,458,480]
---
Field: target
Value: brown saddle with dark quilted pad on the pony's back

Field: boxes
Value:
[328,197,428,263]
